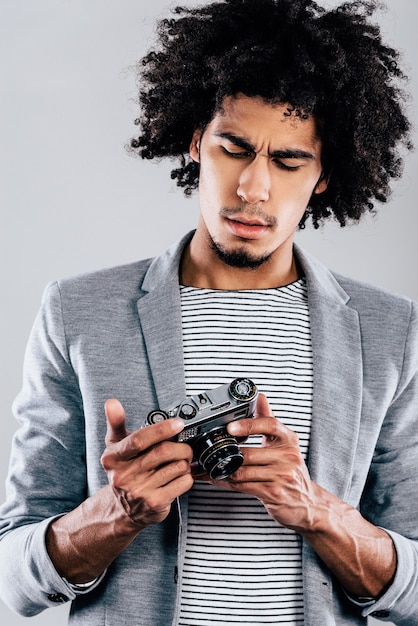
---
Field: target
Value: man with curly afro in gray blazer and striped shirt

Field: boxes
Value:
[0,0,418,626]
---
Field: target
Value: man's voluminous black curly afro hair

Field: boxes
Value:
[130,0,412,228]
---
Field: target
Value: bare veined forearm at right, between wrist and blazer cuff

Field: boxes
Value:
[299,485,397,598]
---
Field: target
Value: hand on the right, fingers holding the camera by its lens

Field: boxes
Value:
[222,394,315,532]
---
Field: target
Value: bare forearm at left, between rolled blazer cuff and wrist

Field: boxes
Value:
[46,486,144,584]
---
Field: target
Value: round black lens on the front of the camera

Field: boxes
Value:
[193,428,244,480]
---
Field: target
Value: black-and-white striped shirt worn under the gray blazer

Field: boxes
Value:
[179,279,312,626]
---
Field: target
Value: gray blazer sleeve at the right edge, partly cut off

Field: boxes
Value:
[361,303,418,626]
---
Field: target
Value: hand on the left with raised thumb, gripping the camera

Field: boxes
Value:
[101,399,193,528]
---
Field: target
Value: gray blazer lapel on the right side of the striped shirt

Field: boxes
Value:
[296,248,363,499]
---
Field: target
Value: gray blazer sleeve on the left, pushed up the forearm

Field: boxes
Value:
[0,283,94,616]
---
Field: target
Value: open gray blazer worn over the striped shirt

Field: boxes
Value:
[0,233,418,626]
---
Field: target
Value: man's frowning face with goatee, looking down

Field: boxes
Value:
[190,95,326,268]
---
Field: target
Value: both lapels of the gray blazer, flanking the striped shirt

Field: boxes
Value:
[137,232,362,498]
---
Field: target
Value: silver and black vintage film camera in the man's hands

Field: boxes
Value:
[146,378,258,480]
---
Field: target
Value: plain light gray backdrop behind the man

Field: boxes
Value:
[0,0,418,626]
